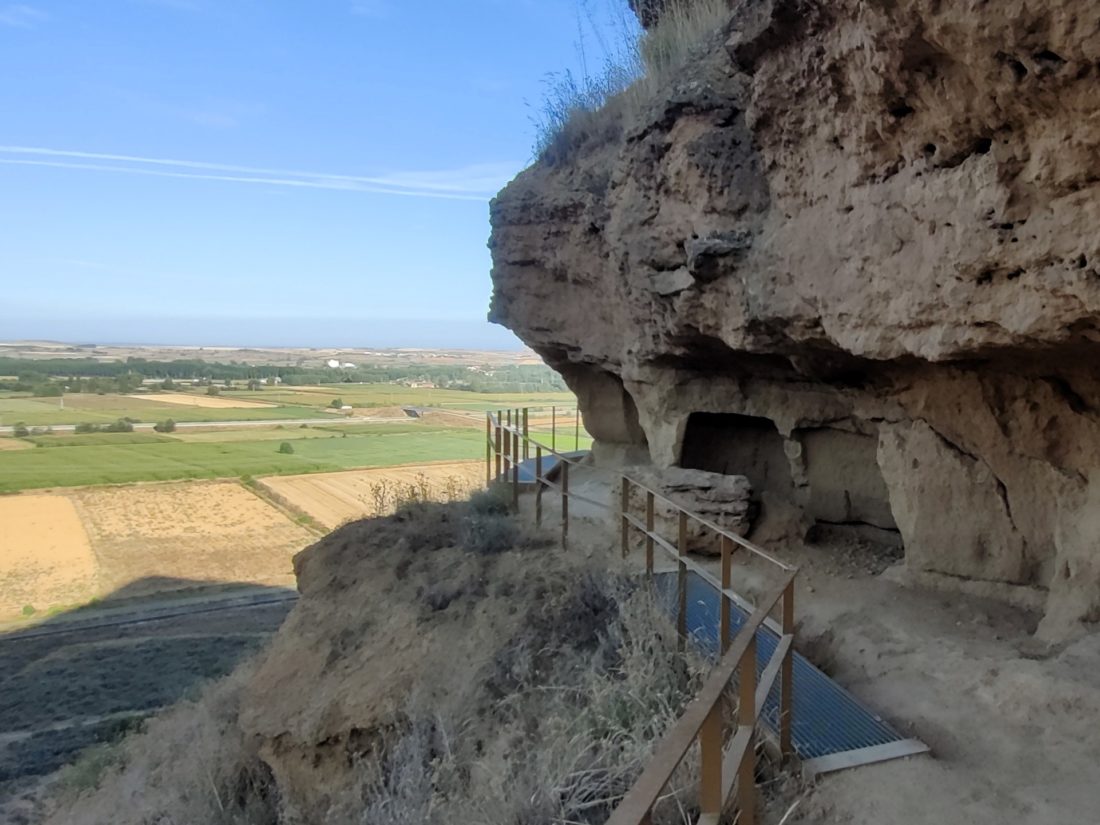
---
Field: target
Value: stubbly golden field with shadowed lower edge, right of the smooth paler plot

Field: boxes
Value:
[68,482,315,597]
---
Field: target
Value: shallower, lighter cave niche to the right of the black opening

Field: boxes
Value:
[793,427,901,558]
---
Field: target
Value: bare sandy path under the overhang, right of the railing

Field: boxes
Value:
[525,471,1100,825]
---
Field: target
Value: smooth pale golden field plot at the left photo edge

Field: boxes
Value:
[0,495,97,619]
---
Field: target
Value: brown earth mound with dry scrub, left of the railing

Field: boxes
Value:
[48,493,730,825]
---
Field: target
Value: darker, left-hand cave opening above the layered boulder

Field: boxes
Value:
[680,413,793,501]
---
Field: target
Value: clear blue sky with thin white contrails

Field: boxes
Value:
[0,0,638,349]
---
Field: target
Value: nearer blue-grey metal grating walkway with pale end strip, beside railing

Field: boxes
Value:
[653,572,928,774]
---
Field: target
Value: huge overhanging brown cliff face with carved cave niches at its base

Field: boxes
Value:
[491,0,1100,637]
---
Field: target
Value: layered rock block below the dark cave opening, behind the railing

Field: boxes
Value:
[625,468,757,556]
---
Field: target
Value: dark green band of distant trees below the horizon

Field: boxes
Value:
[0,356,567,396]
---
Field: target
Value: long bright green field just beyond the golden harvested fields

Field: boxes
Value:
[0,424,485,493]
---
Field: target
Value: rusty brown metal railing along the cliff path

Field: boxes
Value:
[485,410,798,825]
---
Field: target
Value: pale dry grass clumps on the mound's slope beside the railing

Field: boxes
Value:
[363,579,702,825]
